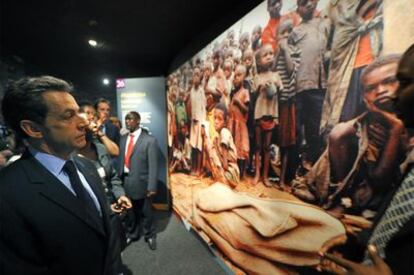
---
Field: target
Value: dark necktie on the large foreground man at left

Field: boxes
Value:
[63,160,100,219]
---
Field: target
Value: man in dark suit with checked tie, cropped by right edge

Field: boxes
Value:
[325,45,414,275]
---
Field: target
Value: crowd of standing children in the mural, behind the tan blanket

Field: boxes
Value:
[167,0,362,192]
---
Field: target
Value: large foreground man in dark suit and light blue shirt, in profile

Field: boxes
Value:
[0,76,115,275]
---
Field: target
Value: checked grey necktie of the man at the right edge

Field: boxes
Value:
[364,167,414,263]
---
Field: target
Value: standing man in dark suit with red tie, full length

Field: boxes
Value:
[118,112,159,250]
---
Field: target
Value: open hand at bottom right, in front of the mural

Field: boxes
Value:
[321,245,392,275]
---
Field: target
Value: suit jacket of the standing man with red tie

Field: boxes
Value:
[118,129,159,200]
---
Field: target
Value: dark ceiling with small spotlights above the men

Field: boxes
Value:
[0,0,262,94]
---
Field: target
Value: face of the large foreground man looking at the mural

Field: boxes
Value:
[42,91,87,156]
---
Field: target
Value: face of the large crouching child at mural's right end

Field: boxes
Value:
[362,63,398,106]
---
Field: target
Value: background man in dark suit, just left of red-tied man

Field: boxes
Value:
[95,98,120,145]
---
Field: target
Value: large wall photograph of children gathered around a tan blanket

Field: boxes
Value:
[167,0,408,274]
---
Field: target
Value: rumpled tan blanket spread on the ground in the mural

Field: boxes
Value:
[194,183,346,274]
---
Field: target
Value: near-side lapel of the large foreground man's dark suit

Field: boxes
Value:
[22,151,105,238]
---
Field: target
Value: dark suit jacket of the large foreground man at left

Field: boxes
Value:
[0,151,113,275]
